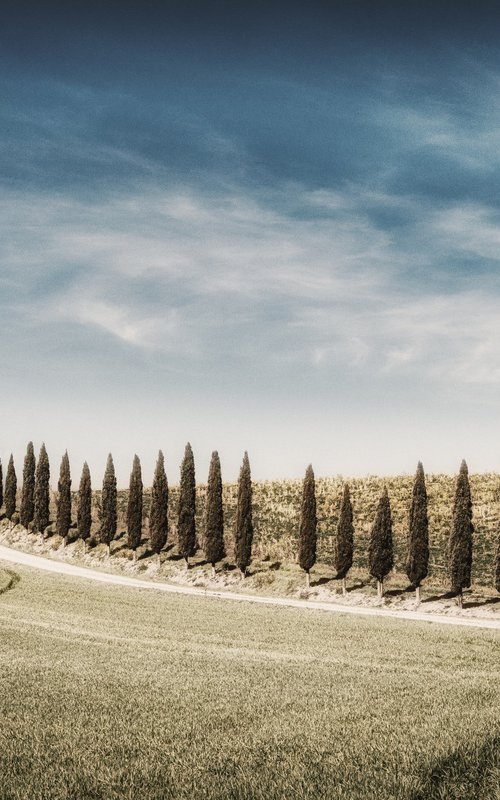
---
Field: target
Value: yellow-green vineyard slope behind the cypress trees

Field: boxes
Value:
[104,473,500,586]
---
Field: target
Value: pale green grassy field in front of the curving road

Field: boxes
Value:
[0,569,500,800]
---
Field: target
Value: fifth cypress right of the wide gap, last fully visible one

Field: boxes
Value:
[448,461,474,608]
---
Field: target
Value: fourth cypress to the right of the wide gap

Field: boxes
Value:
[406,461,429,605]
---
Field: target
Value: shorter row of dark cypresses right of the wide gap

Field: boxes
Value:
[298,461,492,606]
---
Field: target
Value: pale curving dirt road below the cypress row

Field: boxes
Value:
[0,545,500,630]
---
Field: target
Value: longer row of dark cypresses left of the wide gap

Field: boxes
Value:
[0,442,253,576]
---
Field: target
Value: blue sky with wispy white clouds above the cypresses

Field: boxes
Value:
[0,0,500,485]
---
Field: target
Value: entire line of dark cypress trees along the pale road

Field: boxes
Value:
[0,442,500,604]
